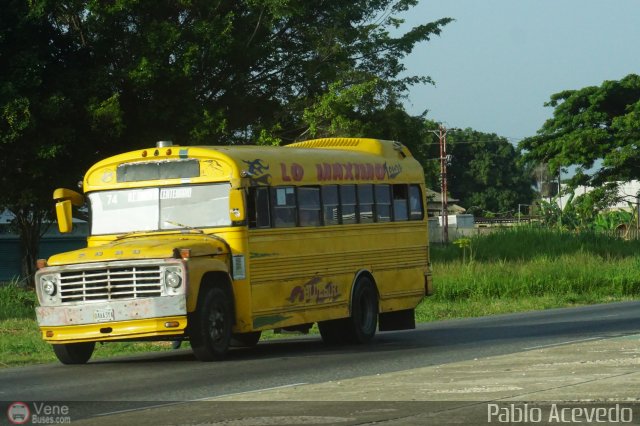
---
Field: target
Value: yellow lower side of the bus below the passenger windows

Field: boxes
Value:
[249,221,427,329]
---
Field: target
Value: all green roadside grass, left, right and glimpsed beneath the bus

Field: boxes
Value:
[0,227,640,367]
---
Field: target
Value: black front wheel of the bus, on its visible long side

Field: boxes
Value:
[189,287,233,362]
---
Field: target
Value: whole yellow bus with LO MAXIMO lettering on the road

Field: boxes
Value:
[36,138,431,364]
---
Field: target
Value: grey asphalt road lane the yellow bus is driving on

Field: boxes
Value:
[0,302,640,420]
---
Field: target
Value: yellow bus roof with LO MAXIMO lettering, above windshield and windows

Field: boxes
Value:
[84,138,424,192]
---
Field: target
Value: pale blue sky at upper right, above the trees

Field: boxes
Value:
[401,0,640,143]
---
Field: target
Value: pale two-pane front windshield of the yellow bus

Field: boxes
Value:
[88,183,231,235]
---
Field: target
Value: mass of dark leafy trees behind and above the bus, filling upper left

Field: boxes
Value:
[0,0,450,282]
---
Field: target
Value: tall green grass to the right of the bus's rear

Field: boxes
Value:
[417,227,640,321]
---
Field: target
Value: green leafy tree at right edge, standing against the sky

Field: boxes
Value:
[520,74,640,186]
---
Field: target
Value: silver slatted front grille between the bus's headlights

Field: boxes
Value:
[60,266,162,303]
